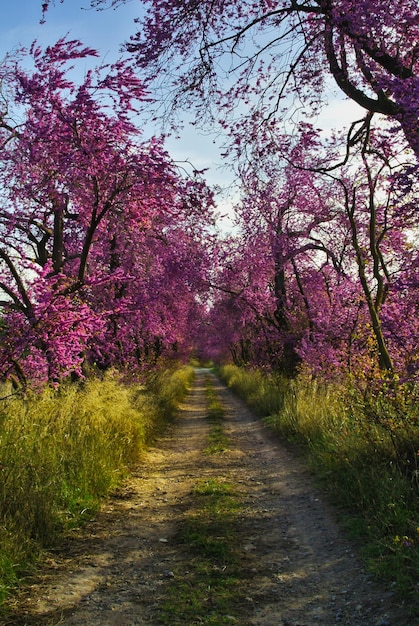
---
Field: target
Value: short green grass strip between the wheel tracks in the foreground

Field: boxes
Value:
[160,479,241,626]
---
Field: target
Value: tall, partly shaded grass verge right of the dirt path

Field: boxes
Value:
[220,366,419,601]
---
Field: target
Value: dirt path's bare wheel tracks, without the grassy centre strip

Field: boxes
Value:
[5,370,415,626]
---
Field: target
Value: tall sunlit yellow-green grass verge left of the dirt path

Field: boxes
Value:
[0,368,193,603]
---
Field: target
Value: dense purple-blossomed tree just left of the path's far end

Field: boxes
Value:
[89,163,218,371]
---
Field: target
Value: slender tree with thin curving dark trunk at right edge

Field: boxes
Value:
[294,118,418,373]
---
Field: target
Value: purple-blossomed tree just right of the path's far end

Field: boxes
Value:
[207,149,354,375]
